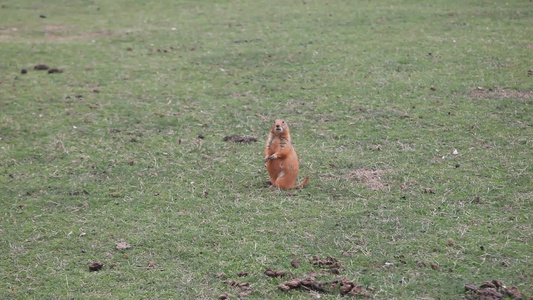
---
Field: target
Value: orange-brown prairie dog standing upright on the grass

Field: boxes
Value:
[265,120,309,190]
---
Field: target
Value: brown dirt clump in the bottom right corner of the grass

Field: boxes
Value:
[465,279,523,300]
